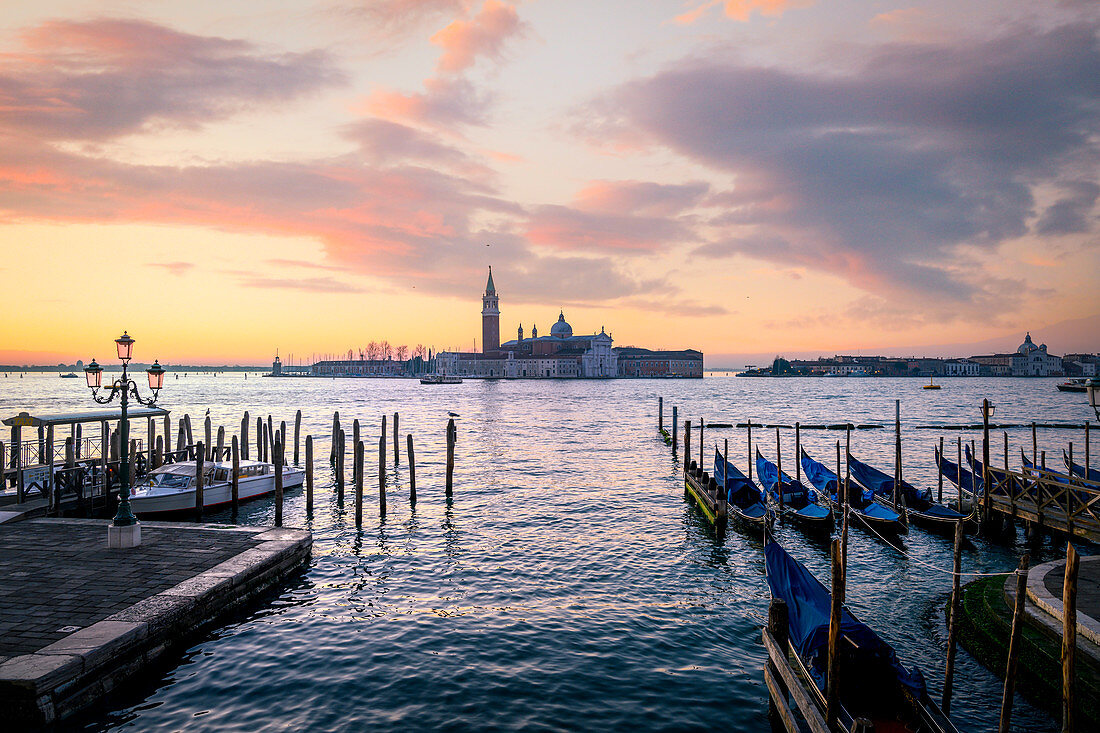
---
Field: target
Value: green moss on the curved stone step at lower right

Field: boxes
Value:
[958,577,1100,730]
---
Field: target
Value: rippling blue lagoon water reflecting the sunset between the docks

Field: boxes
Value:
[0,374,1098,731]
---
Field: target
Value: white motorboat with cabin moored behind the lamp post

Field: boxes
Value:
[130,461,306,514]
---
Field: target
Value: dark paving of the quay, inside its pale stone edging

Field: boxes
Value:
[0,519,262,663]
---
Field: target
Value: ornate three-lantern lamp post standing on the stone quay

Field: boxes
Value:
[84,331,164,547]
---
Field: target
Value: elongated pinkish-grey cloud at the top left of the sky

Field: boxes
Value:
[0,20,344,141]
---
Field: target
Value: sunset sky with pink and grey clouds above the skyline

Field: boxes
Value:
[0,0,1100,364]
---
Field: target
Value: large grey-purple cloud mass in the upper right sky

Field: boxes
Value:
[590,24,1100,304]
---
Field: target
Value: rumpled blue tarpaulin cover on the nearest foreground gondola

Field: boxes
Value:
[763,541,927,701]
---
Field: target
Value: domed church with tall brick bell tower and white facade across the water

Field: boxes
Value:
[438,267,618,379]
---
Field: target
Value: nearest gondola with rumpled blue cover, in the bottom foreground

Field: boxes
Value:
[763,541,958,733]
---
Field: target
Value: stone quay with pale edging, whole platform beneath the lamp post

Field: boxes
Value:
[0,518,312,730]
